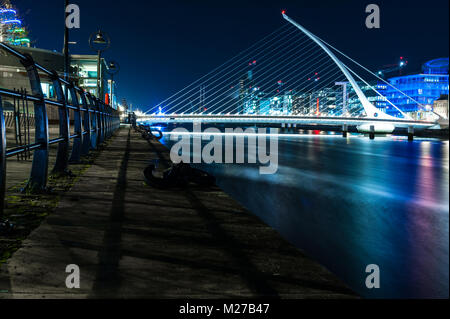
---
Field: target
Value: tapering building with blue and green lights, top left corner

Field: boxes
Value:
[0,0,30,47]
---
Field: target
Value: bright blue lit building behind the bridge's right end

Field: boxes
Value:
[377,58,449,119]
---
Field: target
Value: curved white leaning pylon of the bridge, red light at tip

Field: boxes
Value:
[282,12,397,120]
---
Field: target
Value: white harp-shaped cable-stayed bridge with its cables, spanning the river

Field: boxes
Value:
[137,12,448,133]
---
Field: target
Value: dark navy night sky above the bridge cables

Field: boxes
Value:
[12,0,449,109]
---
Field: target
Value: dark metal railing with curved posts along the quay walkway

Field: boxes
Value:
[0,43,120,218]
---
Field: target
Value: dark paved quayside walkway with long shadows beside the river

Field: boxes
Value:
[0,128,355,298]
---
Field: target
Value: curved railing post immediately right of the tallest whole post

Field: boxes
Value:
[51,71,70,173]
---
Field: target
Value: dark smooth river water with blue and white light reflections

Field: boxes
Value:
[158,128,449,298]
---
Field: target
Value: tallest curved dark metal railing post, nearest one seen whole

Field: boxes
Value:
[20,54,48,192]
